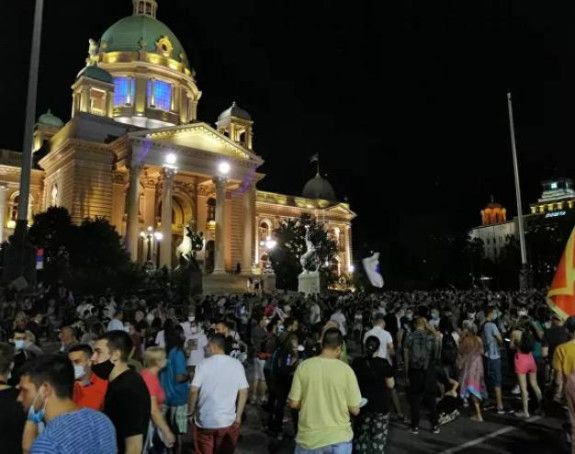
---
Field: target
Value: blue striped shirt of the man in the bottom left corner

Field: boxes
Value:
[30,408,118,454]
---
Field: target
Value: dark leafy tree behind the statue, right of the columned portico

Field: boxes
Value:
[270,214,337,290]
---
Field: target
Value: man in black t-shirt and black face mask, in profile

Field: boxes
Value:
[92,331,151,454]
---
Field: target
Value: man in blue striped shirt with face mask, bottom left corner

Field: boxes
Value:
[18,355,116,454]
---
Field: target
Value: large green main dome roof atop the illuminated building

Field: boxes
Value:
[100,15,188,66]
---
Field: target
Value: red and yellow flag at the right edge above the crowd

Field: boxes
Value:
[547,229,575,319]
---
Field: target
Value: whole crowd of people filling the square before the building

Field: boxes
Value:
[0,285,575,454]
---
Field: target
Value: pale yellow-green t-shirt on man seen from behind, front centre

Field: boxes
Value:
[289,357,361,450]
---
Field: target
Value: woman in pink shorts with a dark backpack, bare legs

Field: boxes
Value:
[510,316,542,418]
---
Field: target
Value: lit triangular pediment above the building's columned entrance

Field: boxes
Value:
[130,122,263,166]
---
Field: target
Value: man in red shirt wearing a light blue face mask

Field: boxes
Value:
[68,344,108,411]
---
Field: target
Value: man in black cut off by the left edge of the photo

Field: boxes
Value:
[0,343,26,454]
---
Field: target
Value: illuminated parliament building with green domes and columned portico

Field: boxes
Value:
[0,0,355,273]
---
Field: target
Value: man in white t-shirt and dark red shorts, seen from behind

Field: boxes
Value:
[188,334,249,454]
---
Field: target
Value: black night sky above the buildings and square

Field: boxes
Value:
[0,0,575,254]
